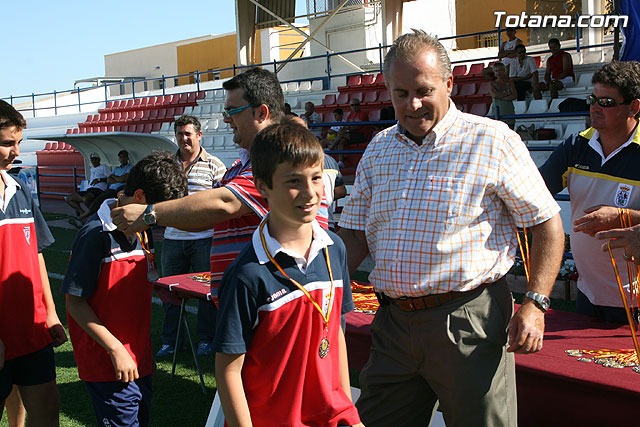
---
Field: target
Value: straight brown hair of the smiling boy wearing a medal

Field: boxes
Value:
[251,121,324,188]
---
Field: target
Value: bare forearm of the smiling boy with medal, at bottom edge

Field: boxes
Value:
[216,353,252,427]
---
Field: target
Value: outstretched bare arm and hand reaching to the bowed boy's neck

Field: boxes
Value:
[111,187,252,234]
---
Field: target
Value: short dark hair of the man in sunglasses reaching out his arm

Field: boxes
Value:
[222,68,284,121]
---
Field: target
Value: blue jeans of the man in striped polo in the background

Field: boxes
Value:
[160,237,217,347]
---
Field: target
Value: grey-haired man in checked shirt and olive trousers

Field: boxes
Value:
[340,31,564,427]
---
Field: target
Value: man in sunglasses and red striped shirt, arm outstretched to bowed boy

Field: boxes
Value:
[111,68,284,292]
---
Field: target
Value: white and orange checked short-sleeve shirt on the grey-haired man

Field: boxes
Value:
[340,103,560,298]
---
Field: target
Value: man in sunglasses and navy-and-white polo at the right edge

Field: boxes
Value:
[540,61,640,323]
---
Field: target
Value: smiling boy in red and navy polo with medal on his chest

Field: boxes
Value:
[214,123,361,427]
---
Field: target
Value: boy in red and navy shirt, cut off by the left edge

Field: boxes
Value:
[0,100,67,426]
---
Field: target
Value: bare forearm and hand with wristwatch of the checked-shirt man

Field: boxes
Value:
[507,214,564,353]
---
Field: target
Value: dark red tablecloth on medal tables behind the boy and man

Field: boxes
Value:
[156,274,640,427]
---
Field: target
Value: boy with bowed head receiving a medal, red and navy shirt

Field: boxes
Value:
[62,152,187,426]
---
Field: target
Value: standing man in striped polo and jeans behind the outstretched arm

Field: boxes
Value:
[156,115,227,356]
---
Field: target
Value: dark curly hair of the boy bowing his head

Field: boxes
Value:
[124,150,187,203]
